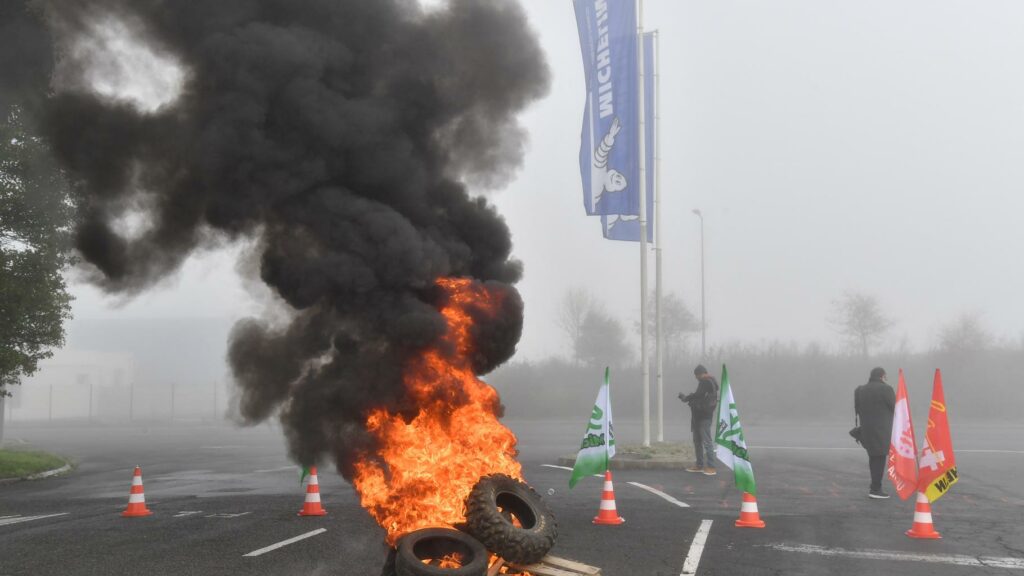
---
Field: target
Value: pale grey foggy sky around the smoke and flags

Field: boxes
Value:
[75,0,1024,359]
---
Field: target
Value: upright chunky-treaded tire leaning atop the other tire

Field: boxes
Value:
[466,474,558,564]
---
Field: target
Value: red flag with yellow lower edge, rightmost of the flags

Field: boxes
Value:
[918,370,958,502]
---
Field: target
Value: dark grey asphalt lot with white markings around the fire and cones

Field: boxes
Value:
[0,421,1024,576]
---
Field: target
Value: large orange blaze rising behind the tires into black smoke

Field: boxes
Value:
[353,279,522,545]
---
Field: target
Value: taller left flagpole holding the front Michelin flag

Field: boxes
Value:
[637,0,650,446]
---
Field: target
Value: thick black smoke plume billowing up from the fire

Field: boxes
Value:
[6,0,548,475]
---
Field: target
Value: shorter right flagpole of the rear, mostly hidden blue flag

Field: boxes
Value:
[653,31,665,442]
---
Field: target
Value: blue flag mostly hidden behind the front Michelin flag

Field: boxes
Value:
[601,32,658,242]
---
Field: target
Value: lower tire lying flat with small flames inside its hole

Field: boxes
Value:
[394,528,490,576]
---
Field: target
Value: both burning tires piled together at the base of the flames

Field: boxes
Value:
[381,474,558,576]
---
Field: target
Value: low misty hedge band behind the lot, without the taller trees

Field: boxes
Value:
[486,342,1024,423]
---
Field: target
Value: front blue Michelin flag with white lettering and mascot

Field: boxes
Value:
[572,0,640,215]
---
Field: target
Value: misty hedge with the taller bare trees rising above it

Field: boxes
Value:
[486,290,1024,423]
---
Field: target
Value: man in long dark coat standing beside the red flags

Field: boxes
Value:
[853,368,896,498]
